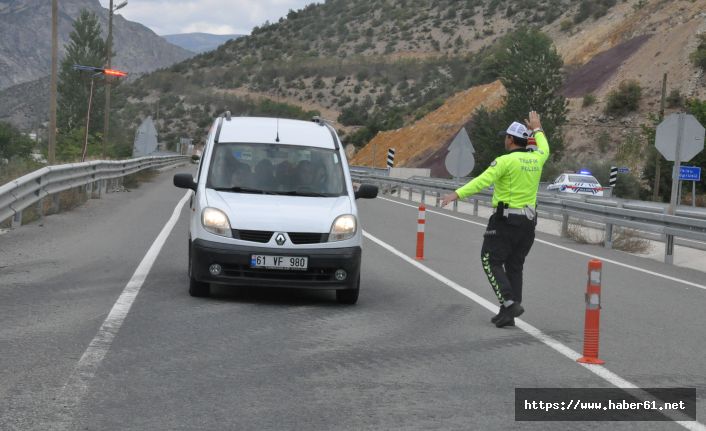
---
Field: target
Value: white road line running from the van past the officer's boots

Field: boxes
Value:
[363,231,706,431]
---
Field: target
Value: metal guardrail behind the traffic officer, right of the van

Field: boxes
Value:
[351,174,706,263]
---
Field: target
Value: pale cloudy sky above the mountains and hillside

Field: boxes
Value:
[100,0,321,35]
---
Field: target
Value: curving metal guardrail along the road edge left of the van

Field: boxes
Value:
[0,156,189,227]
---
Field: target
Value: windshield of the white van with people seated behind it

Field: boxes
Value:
[206,142,347,197]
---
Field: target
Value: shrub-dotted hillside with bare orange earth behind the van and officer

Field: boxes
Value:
[106,0,706,159]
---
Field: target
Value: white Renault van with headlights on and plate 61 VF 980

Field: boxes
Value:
[174,113,378,304]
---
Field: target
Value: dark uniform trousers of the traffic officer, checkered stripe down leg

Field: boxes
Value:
[481,214,537,304]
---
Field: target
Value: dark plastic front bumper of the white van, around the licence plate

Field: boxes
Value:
[190,239,361,290]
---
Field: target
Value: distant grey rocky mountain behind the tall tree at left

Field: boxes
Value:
[0,0,193,89]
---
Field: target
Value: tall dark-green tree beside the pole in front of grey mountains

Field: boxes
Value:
[57,9,106,159]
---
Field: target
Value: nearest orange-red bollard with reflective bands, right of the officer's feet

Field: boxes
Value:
[577,259,605,365]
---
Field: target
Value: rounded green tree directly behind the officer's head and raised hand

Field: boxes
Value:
[470,28,567,174]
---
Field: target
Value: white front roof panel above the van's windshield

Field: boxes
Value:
[218,117,335,149]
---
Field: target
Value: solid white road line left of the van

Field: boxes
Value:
[52,191,191,429]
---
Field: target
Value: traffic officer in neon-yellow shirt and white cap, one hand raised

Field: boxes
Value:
[441,111,549,328]
